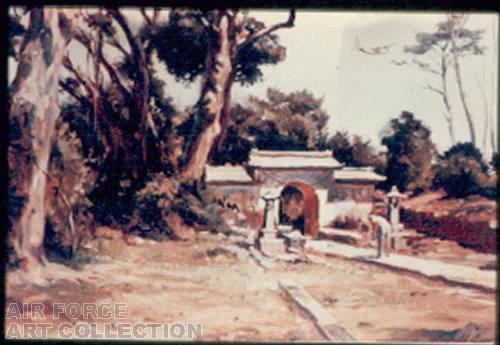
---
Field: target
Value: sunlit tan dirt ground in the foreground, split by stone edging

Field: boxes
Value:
[6,230,496,341]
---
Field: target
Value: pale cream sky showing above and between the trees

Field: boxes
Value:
[9,9,498,157]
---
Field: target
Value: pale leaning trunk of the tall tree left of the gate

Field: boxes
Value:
[182,15,233,180]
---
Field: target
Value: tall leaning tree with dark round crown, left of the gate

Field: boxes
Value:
[150,10,295,180]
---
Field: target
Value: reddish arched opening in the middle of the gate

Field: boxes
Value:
[279,181,319,238]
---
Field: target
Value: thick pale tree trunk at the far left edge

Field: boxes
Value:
[11,7,70,269]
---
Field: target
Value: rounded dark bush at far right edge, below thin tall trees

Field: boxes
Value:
[434,143,496,198]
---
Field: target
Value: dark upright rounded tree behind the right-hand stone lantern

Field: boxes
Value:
[382,111,435,193]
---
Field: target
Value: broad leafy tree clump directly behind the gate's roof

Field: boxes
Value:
[212,89,328,164]
